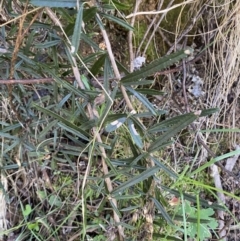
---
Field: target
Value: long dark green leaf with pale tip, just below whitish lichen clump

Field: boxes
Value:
[121,49,192,85]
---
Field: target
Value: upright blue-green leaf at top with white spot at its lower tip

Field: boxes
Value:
[71,4,83,55]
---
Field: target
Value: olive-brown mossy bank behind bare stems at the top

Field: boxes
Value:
[122,0,193,61]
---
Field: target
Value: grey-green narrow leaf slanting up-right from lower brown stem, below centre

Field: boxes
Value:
[112,167,159,195]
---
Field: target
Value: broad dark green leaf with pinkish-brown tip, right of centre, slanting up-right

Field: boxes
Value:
[148,113,198,153]
